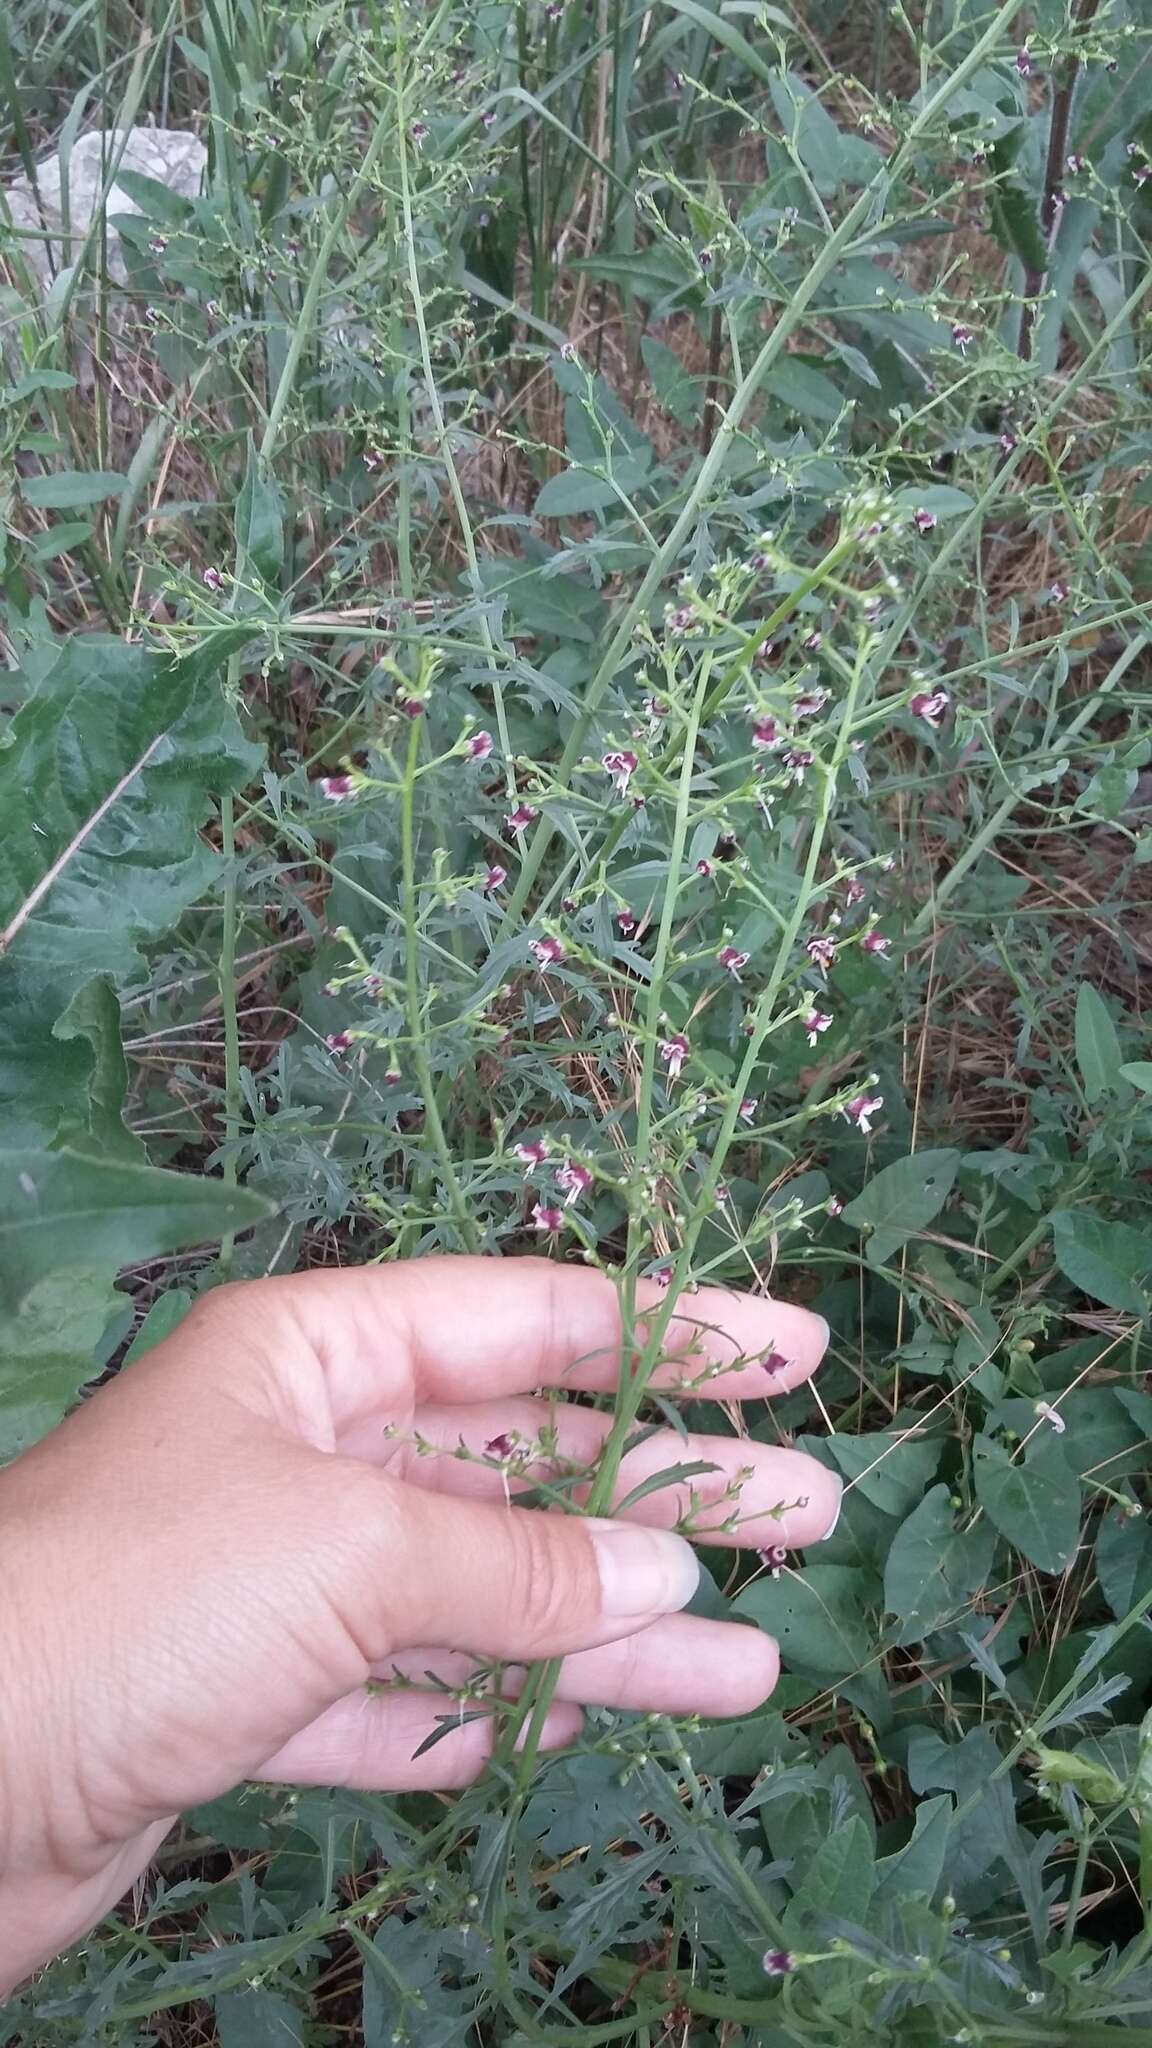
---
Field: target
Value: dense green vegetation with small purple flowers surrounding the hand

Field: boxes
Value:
[0,0,1152,2048]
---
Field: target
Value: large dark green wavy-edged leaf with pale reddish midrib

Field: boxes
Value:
[0,629,262,1145]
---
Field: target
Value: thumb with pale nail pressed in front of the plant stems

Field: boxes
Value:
[340,1473,699,1663]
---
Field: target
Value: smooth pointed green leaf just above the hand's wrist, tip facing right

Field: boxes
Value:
[0,1147,277,1313]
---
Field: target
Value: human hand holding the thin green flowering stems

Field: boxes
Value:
[0,1257,828,1993]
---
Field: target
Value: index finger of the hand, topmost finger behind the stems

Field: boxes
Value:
[269,1257,828,1427]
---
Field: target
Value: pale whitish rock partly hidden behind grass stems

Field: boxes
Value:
[6,127,207,281]
